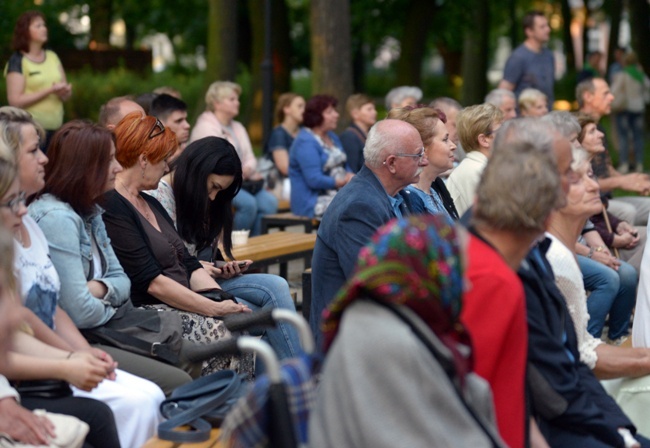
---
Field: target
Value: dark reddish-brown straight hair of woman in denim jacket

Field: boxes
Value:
[43,120,115,215]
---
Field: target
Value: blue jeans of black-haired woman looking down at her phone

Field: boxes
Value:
[217,274,302,370]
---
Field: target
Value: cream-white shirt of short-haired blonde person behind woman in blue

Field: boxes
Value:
[446,151,488,216]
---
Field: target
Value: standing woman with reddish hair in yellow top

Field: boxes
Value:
[5,11,72,150]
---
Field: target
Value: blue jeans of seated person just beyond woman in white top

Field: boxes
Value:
[578,255,638,340]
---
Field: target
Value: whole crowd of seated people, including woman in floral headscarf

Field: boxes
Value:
[6,9,650,448]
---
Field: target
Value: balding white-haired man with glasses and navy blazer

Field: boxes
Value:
[309,120,429,342]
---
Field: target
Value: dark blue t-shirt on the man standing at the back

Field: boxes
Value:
[503,44,555,109]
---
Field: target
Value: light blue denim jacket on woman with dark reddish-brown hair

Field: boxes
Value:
[29,194,131,329]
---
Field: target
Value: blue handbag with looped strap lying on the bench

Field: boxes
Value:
[158,370,243,443]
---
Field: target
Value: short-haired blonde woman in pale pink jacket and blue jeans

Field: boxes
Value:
[190,81,278,235]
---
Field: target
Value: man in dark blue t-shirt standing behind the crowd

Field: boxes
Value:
[499,11,555,109]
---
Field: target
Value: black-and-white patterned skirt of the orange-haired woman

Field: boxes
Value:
[142,304,255,380]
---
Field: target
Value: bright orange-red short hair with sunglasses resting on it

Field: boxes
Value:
[114,112,178,169]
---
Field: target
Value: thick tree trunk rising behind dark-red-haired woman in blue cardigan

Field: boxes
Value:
[310,0,352,103]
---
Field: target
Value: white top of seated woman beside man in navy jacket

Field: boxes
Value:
[546,233,603,369]
